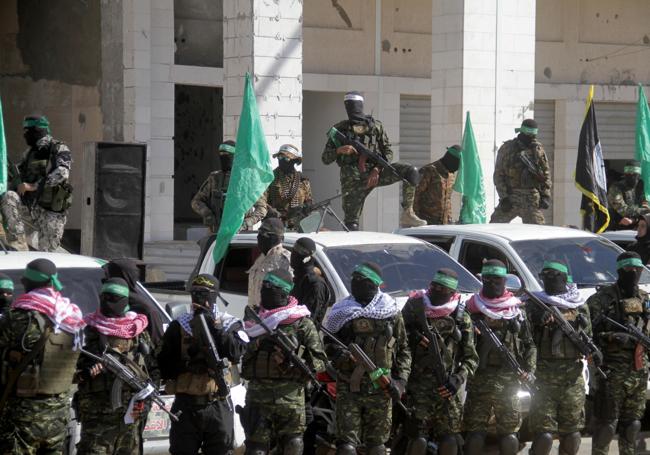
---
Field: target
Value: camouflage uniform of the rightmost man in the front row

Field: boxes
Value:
[587,284,650,455]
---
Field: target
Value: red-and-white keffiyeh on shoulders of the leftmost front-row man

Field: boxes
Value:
[11,287,86,334]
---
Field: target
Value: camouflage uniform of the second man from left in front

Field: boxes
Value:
[77,326,154,455]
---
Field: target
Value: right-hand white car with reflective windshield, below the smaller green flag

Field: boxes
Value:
[396,223,650,298]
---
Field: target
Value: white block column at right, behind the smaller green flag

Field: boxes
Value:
[431,0,535,216]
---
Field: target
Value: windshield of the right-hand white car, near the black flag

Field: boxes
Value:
[511,237,650,287]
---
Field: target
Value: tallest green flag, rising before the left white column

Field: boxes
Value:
[213,73,273,264]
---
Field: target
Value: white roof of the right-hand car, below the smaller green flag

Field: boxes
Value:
[395,223,597,242]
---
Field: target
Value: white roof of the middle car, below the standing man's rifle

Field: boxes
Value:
[235,231,421,248]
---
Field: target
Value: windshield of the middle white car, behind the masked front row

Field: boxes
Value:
[324,243,481,295]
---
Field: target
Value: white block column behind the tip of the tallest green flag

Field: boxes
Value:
[223,0,302,153]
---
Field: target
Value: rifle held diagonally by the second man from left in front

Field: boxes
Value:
[81,349,181,422]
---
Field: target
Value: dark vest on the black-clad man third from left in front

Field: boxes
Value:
[165,329,219,396]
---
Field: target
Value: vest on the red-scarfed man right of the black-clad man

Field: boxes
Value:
[242,322,305,382]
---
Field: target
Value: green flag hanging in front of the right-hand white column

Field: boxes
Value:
[454,112,487,224]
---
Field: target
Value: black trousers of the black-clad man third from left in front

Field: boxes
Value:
[169,394,234,455]
